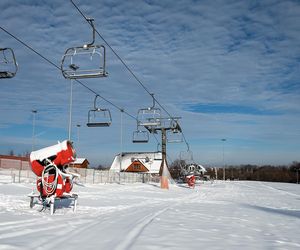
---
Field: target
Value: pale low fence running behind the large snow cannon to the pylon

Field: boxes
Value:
[0,168,159,184]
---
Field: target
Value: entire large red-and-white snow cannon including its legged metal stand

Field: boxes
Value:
[28,140,80,214]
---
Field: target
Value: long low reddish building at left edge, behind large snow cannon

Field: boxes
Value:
[0,155,31,170]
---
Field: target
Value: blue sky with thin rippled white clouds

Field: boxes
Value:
[0,0,300,166]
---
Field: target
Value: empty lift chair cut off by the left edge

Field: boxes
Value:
[0,48,18,79]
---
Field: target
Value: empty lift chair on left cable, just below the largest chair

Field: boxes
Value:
[86,95,112,127]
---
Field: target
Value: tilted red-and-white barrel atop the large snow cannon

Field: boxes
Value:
[30,140,76,177]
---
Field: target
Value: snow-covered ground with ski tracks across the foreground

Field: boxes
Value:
[0,176,300,250]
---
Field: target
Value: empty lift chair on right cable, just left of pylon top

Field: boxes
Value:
[137,94,161,127]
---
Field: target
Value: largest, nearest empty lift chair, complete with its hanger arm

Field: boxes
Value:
[61,19,108,79]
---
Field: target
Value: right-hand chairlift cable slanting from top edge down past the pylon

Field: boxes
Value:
[70,0,189,150]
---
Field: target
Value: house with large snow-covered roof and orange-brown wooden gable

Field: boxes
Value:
[110,152,162,174]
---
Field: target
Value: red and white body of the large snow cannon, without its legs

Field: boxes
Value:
[30,140,79,198]
